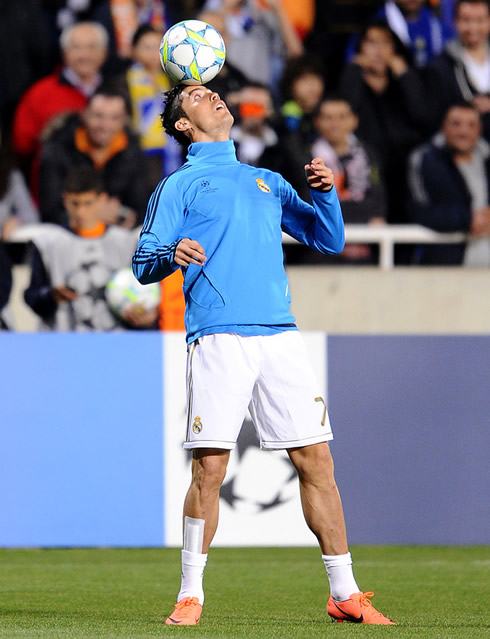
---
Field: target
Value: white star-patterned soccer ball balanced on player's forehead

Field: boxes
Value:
[160,20,226,84]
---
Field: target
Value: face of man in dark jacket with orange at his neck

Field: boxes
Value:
[83,95,127,148]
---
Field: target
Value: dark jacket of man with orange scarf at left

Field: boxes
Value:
[39,115,151,226]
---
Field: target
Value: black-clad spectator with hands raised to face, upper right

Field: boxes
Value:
[340,22,428,223]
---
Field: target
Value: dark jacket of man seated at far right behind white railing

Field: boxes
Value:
[409,142,490,265]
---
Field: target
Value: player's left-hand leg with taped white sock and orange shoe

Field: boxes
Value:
[165,448,230,626]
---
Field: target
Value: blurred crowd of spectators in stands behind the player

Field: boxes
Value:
[0,0,490,330]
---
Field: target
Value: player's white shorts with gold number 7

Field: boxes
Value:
[184,330,333,450]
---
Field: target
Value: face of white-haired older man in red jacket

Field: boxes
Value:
[63,24,107,79]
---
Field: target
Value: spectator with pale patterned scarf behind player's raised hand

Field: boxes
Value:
[311,94,386,264]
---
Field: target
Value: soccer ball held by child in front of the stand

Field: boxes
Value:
[105,268,161,317]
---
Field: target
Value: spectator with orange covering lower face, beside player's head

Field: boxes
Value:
[230,84,278,166]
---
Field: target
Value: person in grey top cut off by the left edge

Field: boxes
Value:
[0,128,39,241]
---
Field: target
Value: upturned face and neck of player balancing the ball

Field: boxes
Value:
[175,85,233,142]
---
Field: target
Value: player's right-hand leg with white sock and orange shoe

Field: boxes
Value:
[288,442,393,625]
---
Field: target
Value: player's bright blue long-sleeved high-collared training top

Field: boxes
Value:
[133,140,344,343]
